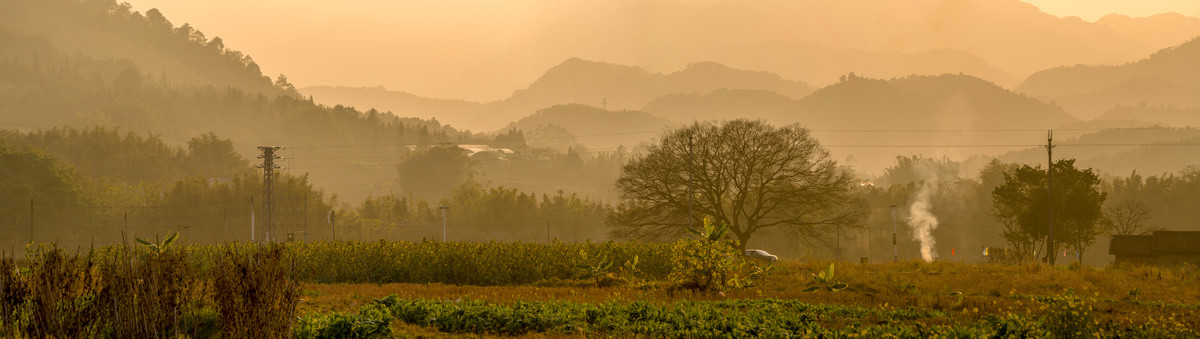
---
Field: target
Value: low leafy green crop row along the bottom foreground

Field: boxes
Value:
[294,296,1200,338]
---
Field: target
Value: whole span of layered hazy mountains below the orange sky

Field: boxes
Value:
[7,0,1200,180]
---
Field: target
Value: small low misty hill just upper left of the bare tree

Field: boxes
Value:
[510,103,673,149]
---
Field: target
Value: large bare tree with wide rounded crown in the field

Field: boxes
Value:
[611,120,865,249]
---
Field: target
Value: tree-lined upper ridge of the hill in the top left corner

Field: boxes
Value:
[0,0,284,95]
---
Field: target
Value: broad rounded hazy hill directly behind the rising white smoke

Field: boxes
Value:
[788,75,1078,173]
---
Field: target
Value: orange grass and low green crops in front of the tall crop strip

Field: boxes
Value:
[290,261,1200,338]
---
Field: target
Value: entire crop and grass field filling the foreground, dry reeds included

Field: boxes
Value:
[0,242,1200,338]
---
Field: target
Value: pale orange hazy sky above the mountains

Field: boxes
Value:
[128,0,1200,101]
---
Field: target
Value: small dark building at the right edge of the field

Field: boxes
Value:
[1109,231,1200,266]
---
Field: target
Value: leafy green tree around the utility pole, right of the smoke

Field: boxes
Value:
[992,159,1106,262]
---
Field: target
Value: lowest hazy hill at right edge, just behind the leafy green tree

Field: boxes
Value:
[998,127,1200,176]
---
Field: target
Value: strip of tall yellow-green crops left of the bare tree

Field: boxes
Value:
[187,242,671,286]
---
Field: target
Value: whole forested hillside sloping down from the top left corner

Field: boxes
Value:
[0,0,487,201]
